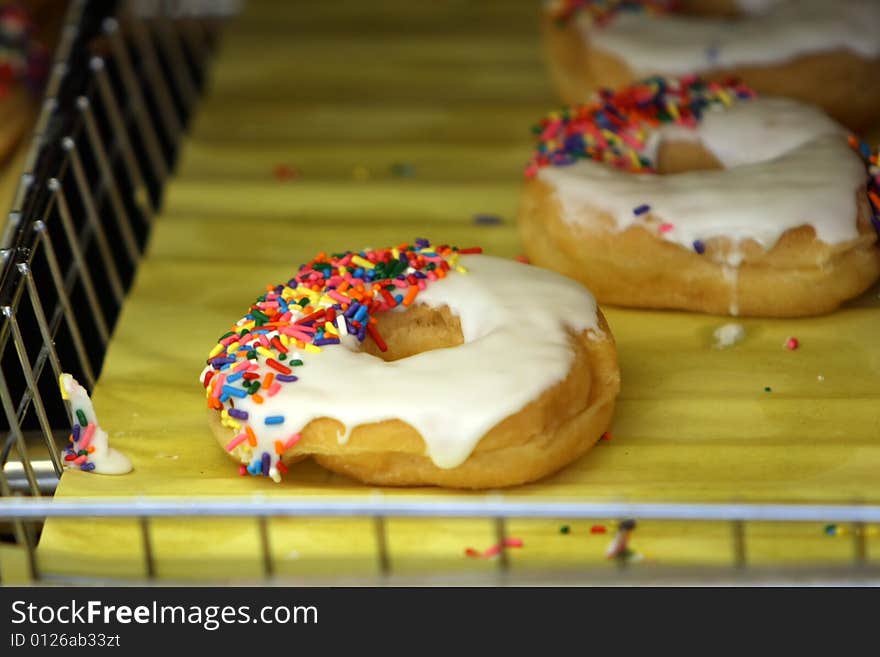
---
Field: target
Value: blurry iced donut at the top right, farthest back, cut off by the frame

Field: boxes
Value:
[543,0,880,130]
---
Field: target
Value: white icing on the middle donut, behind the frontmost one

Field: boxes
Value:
[538,98,866,256]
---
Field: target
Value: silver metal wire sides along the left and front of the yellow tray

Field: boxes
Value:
[0,0,880,583]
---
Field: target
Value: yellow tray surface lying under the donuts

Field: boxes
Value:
[39,0,880,578]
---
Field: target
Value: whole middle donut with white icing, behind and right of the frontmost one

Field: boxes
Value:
[519,78,880,317]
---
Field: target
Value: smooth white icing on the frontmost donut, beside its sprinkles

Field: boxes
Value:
[211,255,599,469]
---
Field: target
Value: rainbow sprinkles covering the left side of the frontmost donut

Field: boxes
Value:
[202,239,482,481]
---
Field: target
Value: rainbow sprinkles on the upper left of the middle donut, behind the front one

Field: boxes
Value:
[525,76,755,178]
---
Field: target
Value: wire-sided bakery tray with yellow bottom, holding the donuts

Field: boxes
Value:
[0,0,880,585]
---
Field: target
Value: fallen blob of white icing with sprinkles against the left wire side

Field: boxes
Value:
[58,374,132,475]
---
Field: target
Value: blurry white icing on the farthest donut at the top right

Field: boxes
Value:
[579,0,880,75]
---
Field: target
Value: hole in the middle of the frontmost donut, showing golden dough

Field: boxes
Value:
[361,305,464,362]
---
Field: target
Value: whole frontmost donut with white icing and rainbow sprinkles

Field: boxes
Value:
[201,240,619,488]
